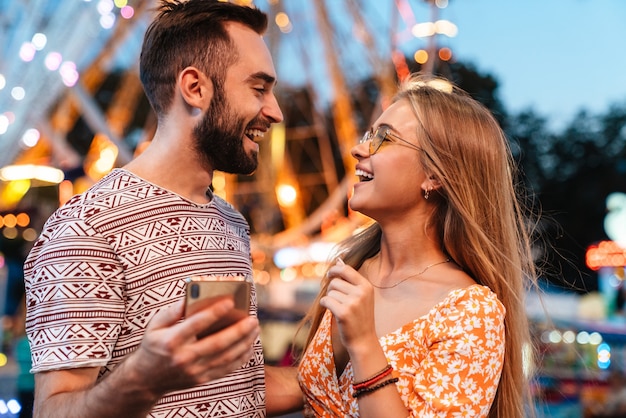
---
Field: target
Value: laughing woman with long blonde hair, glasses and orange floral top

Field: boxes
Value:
[298,75,535,418]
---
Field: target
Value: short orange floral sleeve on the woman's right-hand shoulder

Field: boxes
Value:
[404,286,505,417]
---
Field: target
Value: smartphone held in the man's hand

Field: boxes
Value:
[185,276,251,339]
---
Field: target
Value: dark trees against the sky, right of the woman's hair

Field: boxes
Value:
[507,105,626,292]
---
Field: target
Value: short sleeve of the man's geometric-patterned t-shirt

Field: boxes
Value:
[24,214,125,372]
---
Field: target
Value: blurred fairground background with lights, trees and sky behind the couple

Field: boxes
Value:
[0,0,626,418]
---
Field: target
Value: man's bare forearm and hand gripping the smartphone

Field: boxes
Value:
[35,300,259,418]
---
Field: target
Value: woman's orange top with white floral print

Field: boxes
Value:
[298,285,505,418]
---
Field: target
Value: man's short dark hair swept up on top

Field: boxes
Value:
[139,0,267,117]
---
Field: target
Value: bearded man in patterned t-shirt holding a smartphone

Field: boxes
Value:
[25,0,282,418]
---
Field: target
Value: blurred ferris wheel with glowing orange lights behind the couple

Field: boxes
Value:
[0,0,455,288]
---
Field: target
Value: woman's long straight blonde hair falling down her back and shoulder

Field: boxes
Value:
[303,74,536,418]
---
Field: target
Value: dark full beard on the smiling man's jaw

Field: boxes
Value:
[193,88,259,174]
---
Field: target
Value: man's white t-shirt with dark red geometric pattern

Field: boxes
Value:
[24,169,265,418]
